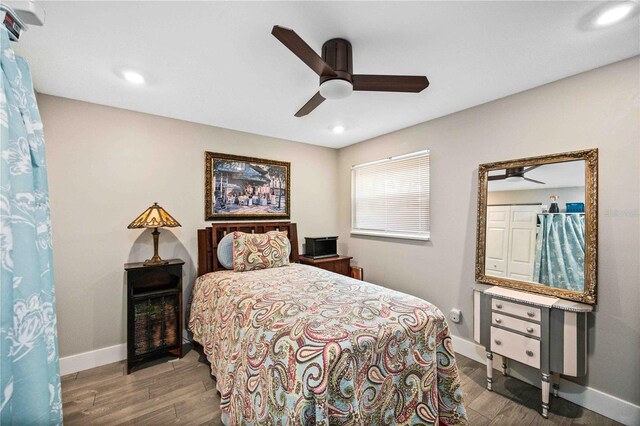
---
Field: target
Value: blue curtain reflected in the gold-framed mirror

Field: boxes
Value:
[533,213,584,291]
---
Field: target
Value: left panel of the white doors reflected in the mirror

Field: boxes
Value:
[484,206,511,277]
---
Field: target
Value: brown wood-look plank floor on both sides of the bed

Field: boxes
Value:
[62,346,619,426]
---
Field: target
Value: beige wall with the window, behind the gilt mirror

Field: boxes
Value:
[338,57,640,404]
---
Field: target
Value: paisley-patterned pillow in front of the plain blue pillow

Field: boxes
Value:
[233,231,291,272]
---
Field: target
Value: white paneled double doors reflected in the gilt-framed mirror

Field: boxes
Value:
[485,205,541,281]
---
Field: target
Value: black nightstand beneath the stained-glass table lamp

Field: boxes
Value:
[124,259,184,374]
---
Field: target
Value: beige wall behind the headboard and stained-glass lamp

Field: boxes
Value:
[38,95,338,357]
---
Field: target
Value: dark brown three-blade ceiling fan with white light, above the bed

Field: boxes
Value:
[271,25,429,117]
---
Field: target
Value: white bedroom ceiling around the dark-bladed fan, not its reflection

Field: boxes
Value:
[15,1,640,147]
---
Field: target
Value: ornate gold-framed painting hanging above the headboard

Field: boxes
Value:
[204,152,291,220]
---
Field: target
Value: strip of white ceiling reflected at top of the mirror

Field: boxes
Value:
[488,160,585,192]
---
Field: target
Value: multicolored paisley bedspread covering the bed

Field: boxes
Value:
[189,264,468,425]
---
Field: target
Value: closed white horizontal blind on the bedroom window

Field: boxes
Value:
[351,150,430,240]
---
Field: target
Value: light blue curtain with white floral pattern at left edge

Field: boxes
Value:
[0,26,62,425]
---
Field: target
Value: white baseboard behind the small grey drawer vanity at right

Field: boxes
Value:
[451,336,640,425]
